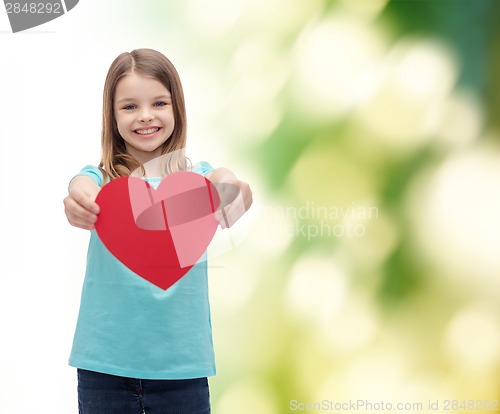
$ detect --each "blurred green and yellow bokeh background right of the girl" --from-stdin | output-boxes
[103,0,500,414]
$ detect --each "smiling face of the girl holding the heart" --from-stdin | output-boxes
[114,72,175,164]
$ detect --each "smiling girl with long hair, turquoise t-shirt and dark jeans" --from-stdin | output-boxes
[64,49,252,414]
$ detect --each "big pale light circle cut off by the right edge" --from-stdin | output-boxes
[409,146,500,293]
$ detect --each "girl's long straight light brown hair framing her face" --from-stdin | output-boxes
[99,49,187,183]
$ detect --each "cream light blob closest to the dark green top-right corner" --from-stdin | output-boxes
[357,39,457,152]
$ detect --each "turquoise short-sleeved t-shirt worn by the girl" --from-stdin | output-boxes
[69,162,215,379]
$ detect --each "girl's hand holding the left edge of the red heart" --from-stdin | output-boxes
[64,175,101,230]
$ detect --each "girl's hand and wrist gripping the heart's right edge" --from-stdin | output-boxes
[206,168,253,229]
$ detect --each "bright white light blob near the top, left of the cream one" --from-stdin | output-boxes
[294,17,385,119]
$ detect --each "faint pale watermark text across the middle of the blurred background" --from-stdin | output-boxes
[263,201,379,241]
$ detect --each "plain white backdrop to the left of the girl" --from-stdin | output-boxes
[0,0,227,414]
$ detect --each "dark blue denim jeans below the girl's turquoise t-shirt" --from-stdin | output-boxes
[77,369,210,414]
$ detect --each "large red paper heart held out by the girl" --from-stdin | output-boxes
[95,171,219,290]
